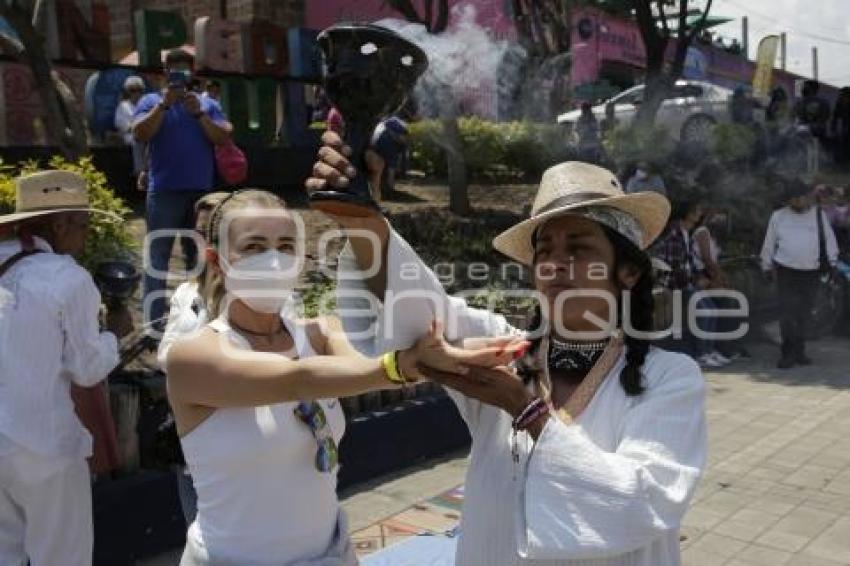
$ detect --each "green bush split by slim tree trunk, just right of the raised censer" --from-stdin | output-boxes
[409,117,570,178]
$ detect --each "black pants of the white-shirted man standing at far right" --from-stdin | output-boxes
[776,265,818,359]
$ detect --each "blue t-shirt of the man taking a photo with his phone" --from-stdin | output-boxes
[133,93,226,191]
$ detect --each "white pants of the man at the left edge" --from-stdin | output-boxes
[0,448,94,566]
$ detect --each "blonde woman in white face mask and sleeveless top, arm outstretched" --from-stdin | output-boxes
[166,191,525,566]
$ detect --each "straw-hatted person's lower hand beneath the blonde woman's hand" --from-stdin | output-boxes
[419,366,534,418]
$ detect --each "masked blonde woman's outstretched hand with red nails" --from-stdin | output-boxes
[399,321,530,380]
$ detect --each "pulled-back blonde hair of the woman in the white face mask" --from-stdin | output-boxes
[205,189,286,320]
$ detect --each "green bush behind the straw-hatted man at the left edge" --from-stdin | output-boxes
[0,156,138,271]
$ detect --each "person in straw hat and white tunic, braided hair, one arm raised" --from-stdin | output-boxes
[307,139,706,566]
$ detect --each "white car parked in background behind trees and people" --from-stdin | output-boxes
[558,80,732,141]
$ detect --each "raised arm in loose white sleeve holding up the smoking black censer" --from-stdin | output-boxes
[307,132,518,434]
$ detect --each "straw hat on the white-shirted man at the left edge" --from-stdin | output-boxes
[0,171,113,229]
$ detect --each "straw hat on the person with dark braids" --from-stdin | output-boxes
[493,161,670,265]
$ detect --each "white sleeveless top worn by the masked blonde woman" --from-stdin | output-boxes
[181,318,347,566]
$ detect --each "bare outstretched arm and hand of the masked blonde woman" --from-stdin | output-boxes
[166,322,511,408]
